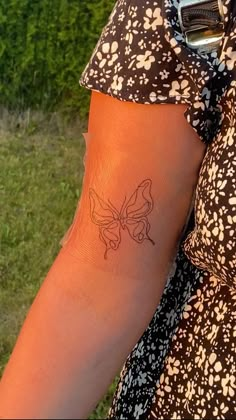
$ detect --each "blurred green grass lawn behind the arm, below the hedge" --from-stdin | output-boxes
[0,130,118,419]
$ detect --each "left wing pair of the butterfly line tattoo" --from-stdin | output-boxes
[89,188,121,259]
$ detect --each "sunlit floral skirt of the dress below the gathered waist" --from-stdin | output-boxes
[147,275,236,420]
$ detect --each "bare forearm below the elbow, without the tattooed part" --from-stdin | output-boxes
[0,250,157,419]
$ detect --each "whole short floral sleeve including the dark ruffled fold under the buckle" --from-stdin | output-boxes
[79,0,232,143]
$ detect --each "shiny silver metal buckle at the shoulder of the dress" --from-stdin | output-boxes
[178,0,224,53]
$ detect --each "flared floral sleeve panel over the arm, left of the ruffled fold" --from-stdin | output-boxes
[80,0,191,104]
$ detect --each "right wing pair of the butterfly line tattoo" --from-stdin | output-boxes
[122,179,155,245]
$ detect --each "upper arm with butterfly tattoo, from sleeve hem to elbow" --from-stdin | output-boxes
[60,91,205,286]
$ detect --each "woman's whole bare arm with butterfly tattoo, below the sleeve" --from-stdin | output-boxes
[0,91,205,419]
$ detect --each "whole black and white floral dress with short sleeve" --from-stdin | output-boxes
[76,0,236,420]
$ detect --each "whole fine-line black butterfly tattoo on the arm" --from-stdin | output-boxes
[89,179,155,259]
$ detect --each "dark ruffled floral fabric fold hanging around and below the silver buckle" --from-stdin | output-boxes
[162,0,234,144]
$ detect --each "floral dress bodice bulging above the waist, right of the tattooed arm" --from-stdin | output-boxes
[183,87,236,290]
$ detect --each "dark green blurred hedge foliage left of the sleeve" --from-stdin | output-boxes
[0,0,115,119]
